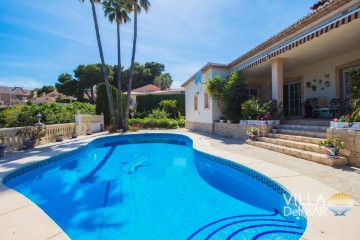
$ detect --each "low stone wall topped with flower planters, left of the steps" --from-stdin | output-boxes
[214,122,273,139]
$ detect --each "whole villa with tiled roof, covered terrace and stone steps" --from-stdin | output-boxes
[182,0,360,167]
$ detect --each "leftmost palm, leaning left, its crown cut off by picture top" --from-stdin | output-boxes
[80,0,116,125]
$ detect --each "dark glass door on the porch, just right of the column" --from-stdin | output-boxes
[284,82,301,117]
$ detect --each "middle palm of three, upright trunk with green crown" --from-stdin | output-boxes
[102,0,130,129]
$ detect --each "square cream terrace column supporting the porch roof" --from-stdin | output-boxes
[271,58,284,103]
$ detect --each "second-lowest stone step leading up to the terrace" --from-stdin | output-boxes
[259,137,326,154]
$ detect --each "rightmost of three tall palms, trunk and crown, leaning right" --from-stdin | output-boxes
[124,0,150,131]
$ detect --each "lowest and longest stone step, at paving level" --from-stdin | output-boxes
[246,140,348,167]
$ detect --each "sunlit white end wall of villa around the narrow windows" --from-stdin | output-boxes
[185,69,226,123]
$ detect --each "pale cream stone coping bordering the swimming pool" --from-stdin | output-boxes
[0,131,360,240]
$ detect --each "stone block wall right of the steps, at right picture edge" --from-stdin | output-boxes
[326,128,360,167]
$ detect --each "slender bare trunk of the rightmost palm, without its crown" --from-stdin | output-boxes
[124,6,137,131]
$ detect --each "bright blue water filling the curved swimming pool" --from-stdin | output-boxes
[4,134,306,240]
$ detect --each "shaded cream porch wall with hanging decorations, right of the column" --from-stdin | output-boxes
[284,49,360,99]
